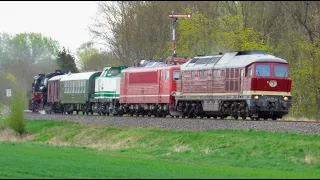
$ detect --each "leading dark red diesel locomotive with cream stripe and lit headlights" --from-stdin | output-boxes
[173,51,292,120]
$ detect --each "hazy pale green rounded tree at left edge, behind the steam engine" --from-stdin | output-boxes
[0,33,59,103]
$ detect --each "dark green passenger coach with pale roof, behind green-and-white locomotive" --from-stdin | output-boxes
[60,71,101,114]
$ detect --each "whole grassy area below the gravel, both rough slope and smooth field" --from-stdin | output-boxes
[0,120,320,179]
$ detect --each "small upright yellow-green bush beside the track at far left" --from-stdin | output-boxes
[7,89,27,135]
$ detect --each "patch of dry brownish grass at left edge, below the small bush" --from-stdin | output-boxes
[0,129,34,142]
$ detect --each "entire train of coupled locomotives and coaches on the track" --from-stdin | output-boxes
[29,51,292,120]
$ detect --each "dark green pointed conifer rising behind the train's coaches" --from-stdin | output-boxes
[57,47,79,73]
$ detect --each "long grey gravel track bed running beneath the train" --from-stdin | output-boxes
[25,112,320,134]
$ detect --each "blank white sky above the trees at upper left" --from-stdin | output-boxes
[0,1,97,54]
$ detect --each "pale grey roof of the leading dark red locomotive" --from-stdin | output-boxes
[181,51,288,70]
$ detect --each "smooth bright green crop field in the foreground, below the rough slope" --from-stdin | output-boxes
[0,143,319,178]
